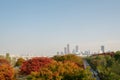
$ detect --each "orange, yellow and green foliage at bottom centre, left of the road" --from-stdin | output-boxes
[27,61,94,80]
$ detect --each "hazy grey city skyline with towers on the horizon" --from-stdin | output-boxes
[56,44,107,56]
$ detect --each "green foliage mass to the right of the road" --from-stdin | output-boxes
[88,51,120,80]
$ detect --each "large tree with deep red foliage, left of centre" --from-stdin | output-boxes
[20,57,52,75]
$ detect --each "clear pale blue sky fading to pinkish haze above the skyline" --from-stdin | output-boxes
[0,0,120,56]
